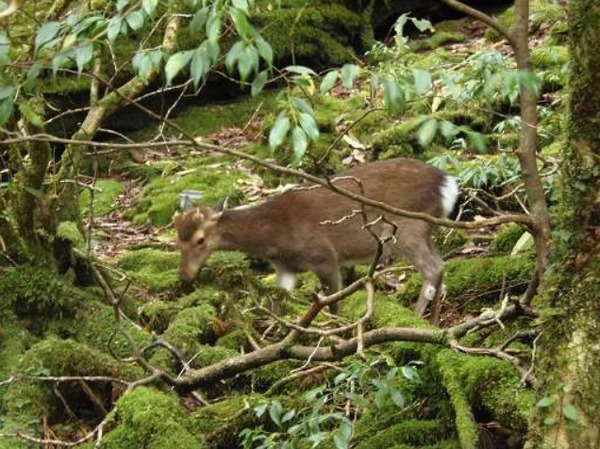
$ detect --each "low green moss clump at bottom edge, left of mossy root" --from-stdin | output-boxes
[354,419,446,449]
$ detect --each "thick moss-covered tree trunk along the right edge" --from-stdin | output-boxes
[527,0,600,449]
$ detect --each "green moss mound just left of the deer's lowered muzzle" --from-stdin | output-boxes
[117,248,181,296]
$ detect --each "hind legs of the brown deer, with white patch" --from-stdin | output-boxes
[397,226,444,323]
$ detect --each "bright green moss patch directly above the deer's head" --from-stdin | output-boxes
[136,163,245,226]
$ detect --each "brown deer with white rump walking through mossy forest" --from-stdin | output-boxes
[174,158,458,315]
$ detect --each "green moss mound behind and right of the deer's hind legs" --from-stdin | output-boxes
[396,255,534,310]
